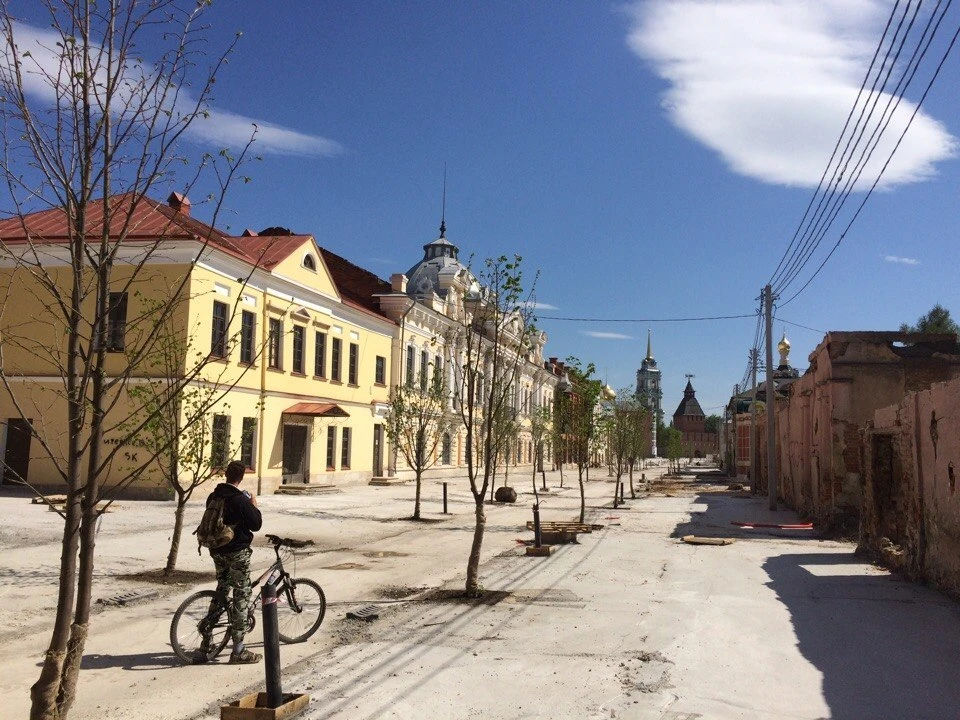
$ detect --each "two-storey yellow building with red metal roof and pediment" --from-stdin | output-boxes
[0,194,397,497]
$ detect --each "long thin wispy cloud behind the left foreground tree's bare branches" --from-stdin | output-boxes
[0,23,344,156]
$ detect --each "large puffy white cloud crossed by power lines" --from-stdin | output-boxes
[627,0,958,189]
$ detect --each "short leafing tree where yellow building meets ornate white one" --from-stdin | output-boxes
[385,367,454,520]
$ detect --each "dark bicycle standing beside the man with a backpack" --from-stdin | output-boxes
[170,535,327,663]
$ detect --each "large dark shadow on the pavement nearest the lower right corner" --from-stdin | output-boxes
[763,552,960,720]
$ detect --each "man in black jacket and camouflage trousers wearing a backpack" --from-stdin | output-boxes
[194,460,263,665]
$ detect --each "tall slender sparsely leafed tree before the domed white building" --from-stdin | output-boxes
[448,256,534,597]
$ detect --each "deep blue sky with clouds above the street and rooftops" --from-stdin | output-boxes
[7,0,960,416]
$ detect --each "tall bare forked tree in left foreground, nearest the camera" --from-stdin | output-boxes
[0,0,255,720]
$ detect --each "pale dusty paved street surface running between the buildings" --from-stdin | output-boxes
[0,464,960,720]
